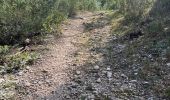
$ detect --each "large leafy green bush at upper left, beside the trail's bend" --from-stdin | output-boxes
[0,0,63,44]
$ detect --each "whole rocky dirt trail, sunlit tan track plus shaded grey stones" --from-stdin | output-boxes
[16,12,169,100]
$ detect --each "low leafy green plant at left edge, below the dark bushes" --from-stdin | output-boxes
[0,52,39,74]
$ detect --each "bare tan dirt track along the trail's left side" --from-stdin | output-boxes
[17,12,97,100]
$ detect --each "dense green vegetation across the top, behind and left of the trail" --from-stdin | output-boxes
[0,0,169,45]
